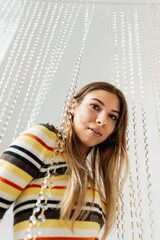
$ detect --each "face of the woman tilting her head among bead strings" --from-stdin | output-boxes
[73,90,120,153]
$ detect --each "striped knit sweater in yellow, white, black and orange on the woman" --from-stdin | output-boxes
[0,124,104,240]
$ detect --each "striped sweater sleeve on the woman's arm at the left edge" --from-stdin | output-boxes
[0,125,56,221]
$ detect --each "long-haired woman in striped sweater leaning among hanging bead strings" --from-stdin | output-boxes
[0,82,128,240]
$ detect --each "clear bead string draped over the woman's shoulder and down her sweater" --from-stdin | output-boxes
[25,4,93,240]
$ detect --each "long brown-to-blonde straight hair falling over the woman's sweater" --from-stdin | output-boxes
[58,82,129,239]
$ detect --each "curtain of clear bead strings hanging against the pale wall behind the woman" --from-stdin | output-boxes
[0,0,160,240]
